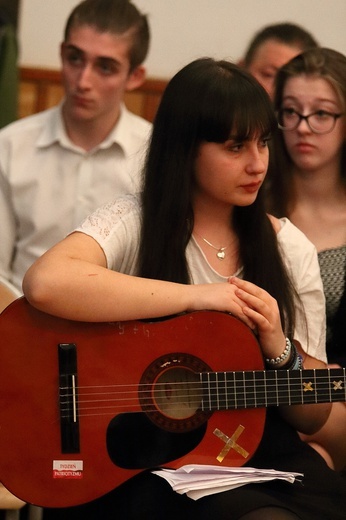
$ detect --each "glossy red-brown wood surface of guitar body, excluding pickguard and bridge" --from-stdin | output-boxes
[0,299,265,507]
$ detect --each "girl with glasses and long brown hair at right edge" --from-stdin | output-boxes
[267,48,346,470]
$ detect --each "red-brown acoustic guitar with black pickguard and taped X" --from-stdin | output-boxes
[0,298,346,507]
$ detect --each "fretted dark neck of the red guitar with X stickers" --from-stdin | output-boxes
[199,368,346,411]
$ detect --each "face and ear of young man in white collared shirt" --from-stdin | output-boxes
[61,25,144,125]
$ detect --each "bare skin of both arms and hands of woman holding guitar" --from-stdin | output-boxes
[23,232,331,433]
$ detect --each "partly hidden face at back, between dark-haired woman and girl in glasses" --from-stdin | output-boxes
[247,39,302,99]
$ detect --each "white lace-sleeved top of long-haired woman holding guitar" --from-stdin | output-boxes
[77,196,326,361]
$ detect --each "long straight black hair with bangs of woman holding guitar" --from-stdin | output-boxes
[139,58,294,334]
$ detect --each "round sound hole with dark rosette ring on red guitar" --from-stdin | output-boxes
[139,353,211,432]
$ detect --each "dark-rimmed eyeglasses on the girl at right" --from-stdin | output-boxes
[277,108,344,134]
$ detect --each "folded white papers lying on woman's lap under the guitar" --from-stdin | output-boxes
[152,464,304,500]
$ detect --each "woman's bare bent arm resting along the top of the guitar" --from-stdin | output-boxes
[23,232,252,326]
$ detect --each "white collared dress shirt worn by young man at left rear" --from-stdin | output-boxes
[0,105,151,289]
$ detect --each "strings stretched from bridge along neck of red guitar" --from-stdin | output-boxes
[60,369,346,417]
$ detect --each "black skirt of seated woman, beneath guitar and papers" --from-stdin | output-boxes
[43,409,346,520]
